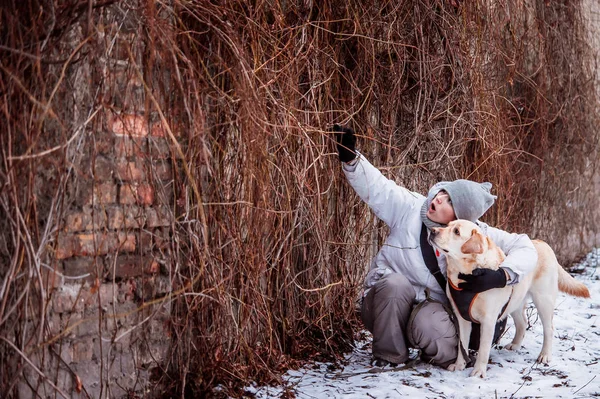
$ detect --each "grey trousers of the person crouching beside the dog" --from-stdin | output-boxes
[361,273,458,367]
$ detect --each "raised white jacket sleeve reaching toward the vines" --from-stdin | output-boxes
[343,154,424,228]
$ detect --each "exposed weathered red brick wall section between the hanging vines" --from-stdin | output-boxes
[19,12,179,398]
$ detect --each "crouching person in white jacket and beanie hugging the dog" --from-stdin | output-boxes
[333,125,537,367]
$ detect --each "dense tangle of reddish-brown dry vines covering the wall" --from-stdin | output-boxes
[0,0,599,397]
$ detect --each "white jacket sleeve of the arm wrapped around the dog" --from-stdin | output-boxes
[479,222,538,285]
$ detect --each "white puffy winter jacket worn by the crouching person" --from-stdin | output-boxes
[342,154,537,302]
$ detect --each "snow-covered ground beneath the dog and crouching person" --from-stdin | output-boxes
[247,249,600,399]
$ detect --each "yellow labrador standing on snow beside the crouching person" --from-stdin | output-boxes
[432,220,590,378]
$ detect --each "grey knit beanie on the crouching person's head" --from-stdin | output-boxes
[442,179,496,222]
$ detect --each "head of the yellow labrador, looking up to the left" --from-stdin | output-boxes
[431,220,489,259]
